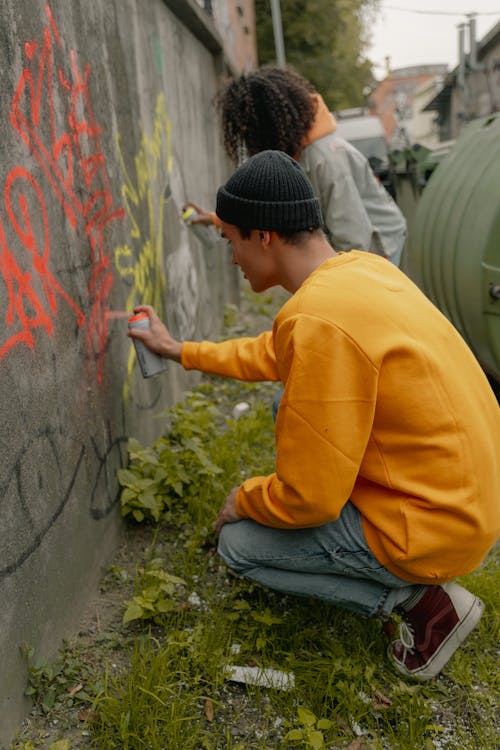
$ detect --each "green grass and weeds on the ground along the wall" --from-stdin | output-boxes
[12,284,500,750]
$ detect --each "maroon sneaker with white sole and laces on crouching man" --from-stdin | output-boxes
[388,583,484,680]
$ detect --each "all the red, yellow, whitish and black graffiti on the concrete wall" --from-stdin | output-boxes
[0,4,203,580]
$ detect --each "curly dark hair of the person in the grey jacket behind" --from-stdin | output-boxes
[216,65,316,163]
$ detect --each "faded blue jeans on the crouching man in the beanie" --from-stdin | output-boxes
[218,502,420,618]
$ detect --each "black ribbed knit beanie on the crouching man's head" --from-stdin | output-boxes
[216,151,323,234]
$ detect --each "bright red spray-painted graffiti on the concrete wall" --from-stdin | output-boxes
[0,5,125,381]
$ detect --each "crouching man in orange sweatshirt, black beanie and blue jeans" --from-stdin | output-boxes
[130,151,500,680]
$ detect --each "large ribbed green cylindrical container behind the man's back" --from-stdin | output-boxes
[407,114,500,383]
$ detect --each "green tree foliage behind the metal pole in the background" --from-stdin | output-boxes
[255,0,378,109]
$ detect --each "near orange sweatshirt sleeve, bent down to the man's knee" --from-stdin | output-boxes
[236,315,378,528]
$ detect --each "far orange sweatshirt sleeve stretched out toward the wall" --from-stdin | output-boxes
[181,331,280,382]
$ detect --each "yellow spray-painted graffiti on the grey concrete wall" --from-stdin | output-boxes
[115,94,172,400]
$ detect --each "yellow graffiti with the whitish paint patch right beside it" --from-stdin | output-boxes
[115,94,203,405]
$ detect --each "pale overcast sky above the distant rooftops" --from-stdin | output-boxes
[366,0,500,80]
